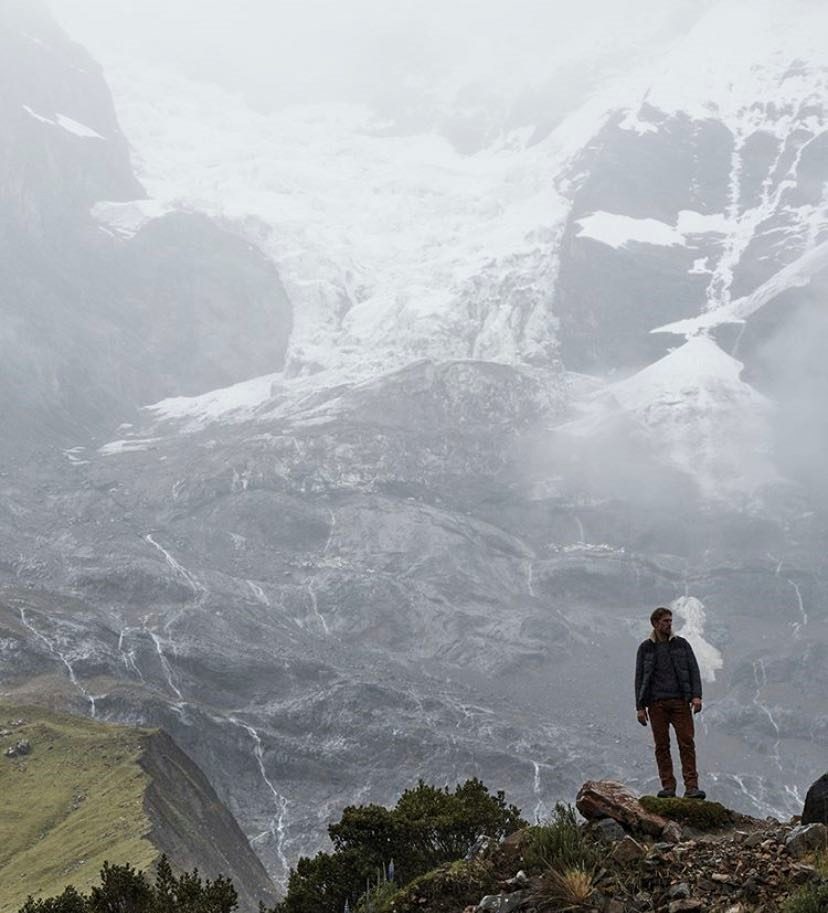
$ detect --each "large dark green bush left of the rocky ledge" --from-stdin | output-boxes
[273,778,526,913]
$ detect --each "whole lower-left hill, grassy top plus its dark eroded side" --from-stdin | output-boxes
[0,702,275,911]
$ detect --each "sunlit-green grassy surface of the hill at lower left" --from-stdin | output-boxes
[0,701,159,913]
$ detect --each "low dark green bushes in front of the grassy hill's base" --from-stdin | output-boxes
[20,856,237,913]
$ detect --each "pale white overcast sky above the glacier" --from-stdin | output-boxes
[49,0,713,106]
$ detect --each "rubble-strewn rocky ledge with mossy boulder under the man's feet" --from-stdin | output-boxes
[388,780,828,913]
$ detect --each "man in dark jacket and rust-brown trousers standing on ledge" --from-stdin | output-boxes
[635,607,705,799]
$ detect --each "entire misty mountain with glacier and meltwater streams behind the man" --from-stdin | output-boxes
[0,3,828,896]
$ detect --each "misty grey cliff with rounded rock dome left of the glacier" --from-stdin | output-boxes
[0,0,291,447]
